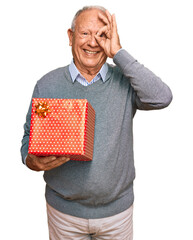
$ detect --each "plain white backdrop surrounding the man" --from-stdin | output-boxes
[0,0,193,240]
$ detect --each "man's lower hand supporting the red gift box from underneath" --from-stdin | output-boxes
[26,154,70,171]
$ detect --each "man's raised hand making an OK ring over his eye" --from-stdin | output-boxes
[95,11,121,58]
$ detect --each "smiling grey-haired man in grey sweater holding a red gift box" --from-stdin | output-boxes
[21,6,172,240]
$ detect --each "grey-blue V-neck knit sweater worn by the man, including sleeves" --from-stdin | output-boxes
[21,50,172,218]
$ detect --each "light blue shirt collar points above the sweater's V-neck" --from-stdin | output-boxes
[69,60,108,82]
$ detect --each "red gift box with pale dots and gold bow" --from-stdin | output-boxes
[28,98,95,161]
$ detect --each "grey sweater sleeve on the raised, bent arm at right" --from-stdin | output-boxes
[113,49,172,110]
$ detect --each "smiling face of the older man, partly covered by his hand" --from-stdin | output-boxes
[68,9,107,72]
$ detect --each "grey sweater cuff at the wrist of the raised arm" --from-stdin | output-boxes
[113,48,136,71]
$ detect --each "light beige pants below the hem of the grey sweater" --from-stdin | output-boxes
[47,204,133,240]
